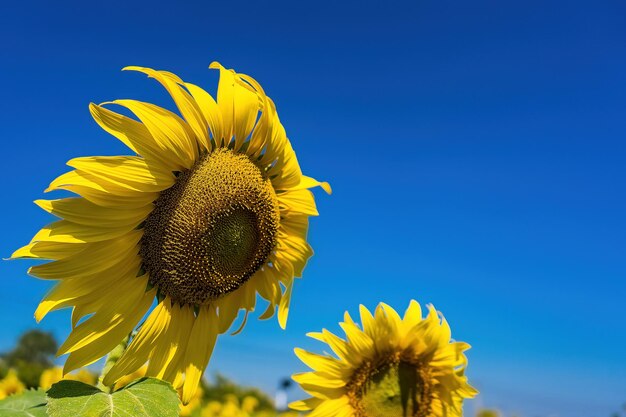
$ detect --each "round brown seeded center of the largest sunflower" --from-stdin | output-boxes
[140,148,280,305]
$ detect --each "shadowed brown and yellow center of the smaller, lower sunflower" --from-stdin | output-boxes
[348,358,432,417]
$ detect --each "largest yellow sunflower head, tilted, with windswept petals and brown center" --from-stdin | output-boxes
[12,62,331,403]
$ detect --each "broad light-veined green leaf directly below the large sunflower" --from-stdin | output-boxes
[48,378,179,417]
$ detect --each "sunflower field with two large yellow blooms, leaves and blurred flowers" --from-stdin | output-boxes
[0,62,478,417]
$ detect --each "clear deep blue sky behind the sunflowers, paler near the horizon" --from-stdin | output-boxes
[0,0,626,417]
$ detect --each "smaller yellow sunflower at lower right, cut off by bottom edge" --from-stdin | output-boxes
[290,300,477,417]
